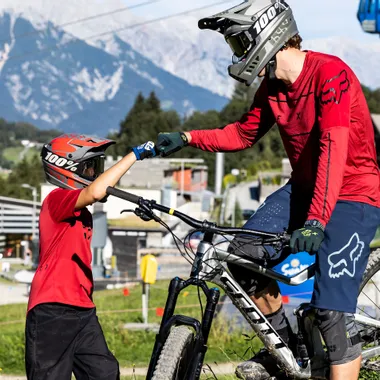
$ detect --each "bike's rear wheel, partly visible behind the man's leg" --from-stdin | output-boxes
[356,249,380,372]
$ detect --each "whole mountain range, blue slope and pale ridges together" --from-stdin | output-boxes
[0,0,380,134]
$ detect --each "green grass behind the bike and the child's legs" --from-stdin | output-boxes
[0,281,379,380]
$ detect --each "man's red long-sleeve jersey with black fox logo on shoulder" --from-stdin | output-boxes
[190,51,380,225]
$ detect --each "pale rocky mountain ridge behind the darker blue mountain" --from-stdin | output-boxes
[0,0,380,97]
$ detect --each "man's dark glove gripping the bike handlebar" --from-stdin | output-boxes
[290,220,325,255]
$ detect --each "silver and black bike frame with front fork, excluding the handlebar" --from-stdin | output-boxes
[147,234,380,380]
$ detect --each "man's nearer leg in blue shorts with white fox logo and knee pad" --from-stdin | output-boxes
[311,201,378,380]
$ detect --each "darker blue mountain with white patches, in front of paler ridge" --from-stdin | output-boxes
[0,11,227,134]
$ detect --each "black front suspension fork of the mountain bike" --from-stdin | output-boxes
[146,277,220,380]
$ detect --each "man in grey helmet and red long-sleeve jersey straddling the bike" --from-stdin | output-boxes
[157,0,380,380]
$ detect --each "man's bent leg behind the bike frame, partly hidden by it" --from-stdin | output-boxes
[228,184,309,343]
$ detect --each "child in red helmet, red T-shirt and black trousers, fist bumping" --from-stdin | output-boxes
[25,134,155,380]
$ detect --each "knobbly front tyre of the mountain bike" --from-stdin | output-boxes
[152,326,194,380]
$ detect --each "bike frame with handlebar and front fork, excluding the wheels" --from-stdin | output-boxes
[107,187,380,380]
